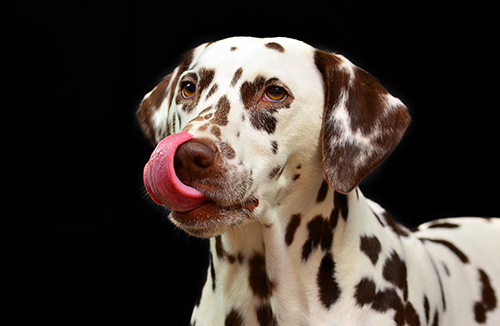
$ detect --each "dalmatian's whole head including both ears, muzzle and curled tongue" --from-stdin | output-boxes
[137,37,410,236]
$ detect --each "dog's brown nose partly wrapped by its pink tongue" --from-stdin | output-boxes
[174,140,217,186]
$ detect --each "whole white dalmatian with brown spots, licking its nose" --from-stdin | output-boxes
[137,37,500,326]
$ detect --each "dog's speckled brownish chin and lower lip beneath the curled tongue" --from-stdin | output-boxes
[170,197,259,238]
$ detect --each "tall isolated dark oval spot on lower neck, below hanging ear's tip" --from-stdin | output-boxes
[317,252,341,309]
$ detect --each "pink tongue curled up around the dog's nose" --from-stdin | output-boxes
[143,132,207,212]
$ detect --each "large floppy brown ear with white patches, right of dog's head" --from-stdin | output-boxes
[315,50,411,193]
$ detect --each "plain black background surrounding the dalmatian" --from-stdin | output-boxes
[29,1,500,325]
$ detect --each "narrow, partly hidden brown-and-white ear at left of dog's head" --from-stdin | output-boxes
[136,50,194,146]
